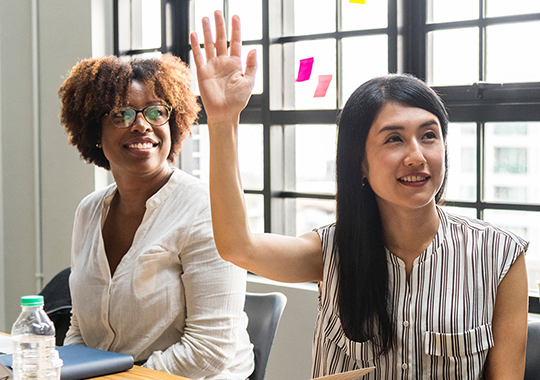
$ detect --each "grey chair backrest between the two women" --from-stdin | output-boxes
[244,292,287,380]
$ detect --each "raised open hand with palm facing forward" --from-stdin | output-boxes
[190,11,257,121]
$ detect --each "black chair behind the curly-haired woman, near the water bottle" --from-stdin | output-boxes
[39,268,71,346]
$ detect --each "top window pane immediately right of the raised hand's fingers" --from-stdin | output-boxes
[229,0,262,41]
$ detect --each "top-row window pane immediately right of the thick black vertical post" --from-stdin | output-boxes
[427,0,479,23]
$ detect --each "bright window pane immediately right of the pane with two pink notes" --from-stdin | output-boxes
[341,34,388,103]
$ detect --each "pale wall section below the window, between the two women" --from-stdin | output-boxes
[247,275,318,380]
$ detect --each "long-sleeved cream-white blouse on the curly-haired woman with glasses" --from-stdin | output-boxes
[65,169,254,379]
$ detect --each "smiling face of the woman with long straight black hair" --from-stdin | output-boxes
[363,103,445,211]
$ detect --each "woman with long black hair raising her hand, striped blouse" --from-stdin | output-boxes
[191,12,528,379]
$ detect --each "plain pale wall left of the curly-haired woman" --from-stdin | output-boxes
[0,0,112,332]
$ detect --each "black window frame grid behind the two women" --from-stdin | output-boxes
[114,0,540,313]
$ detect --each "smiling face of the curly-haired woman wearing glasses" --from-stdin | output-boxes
[101,80,171,178]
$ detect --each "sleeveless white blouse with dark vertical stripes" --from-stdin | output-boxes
[312,208,528,380]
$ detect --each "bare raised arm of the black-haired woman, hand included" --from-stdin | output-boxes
[191,11,323,282]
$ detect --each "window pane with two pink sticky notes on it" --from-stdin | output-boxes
[283,39,337,109]
